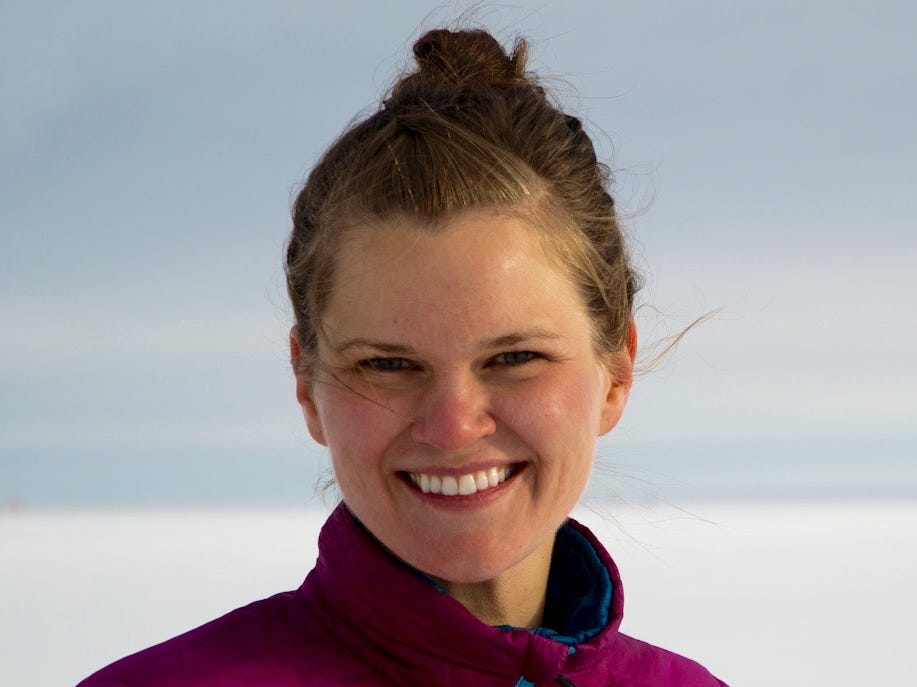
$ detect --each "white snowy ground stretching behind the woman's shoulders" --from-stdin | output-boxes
[0,502,917,687]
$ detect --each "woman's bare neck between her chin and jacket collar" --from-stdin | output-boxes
[436,542,553,627]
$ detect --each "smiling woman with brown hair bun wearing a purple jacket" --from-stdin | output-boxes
[82,30,723,687]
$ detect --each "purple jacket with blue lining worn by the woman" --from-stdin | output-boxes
[78,504,724,687]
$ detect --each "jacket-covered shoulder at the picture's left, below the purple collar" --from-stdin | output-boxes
[77,591,374,687]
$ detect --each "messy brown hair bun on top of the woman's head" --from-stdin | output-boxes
[414,29,527,88]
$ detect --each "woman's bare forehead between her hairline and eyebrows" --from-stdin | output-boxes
[323,213,589,346]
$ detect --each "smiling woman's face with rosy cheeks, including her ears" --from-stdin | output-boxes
[293,213,633,582]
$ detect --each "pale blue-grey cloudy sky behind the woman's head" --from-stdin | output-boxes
[0,1,917,509]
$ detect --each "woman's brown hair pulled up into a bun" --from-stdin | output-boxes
[286,29,639,367]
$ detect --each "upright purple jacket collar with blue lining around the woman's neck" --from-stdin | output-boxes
[300,503,623,684]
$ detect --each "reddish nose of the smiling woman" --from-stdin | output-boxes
[411,374,497,451]
